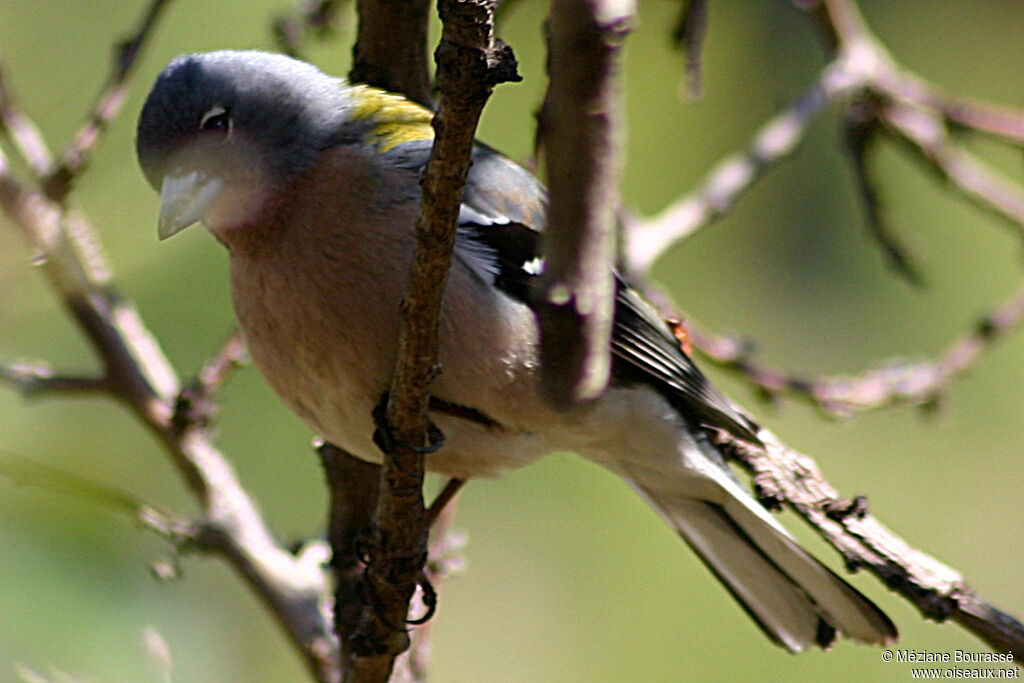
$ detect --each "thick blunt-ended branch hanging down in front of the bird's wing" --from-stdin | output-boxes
[538,0,634,408]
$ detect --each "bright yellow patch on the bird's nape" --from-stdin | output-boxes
[351,85,434,152]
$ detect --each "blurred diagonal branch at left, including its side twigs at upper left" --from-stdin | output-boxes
[0,10,337,681]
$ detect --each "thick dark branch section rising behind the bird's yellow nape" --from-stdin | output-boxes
[348,0,433,106]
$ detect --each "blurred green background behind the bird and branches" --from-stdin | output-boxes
[0,0,1024,682]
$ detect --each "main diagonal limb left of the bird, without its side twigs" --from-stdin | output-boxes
[0,163,330,679]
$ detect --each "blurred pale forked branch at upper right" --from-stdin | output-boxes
[627,0,1024,273]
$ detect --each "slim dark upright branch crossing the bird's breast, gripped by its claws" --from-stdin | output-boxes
[344,0,518,681]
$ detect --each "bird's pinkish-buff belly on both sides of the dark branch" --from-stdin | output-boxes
[231,248,553,478]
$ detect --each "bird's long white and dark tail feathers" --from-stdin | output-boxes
[628,444,897,652]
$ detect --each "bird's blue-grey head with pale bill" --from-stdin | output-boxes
[136,50,351,239]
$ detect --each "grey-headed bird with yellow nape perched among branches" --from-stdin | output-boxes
[137,51,896,651]
